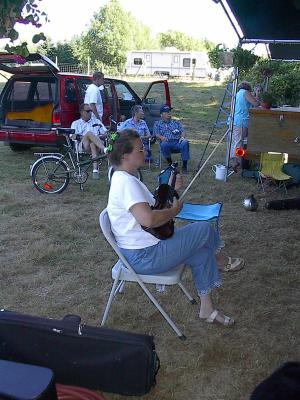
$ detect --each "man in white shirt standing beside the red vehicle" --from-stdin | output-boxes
[84,72,104,121]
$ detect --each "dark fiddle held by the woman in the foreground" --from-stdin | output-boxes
[142,162,179,240]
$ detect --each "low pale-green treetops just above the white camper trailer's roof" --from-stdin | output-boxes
[158,30,213,51]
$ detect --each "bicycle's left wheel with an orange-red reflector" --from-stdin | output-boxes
[32,156,70,194]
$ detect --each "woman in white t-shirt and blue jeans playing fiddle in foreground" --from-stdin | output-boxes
[107,129,243,326]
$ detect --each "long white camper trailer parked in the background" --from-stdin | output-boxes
[125,49,211,78]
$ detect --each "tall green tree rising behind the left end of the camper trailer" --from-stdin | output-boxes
[75,0,152,71]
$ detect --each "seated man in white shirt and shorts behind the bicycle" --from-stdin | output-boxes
[71,104,107,179]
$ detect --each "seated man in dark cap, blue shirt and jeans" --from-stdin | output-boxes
[153,105,190,174]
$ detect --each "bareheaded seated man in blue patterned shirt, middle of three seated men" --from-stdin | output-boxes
[119,105,152,162]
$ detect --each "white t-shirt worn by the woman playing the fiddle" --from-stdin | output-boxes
[107,171,159,249]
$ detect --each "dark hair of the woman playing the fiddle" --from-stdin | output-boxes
[108,129,140,167]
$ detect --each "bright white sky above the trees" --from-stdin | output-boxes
[13,0,238,47]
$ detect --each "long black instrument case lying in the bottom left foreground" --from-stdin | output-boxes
[0,310,159,396]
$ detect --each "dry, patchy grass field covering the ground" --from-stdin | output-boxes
[0,82,300,400]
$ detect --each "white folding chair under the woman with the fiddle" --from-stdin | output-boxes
[99,209,196,340]
